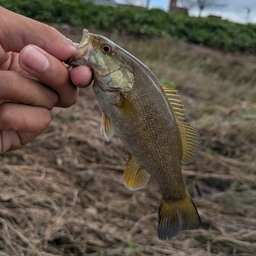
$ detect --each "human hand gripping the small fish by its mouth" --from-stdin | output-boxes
[0,7,91,154]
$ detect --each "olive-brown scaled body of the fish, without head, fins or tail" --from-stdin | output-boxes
[94,65,185,200]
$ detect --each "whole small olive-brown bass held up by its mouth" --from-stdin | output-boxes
[67,29,201,240]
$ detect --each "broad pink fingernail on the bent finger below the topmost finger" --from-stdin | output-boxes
[23,46,50,73]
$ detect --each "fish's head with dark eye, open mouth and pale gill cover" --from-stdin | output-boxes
[68,29,134,91]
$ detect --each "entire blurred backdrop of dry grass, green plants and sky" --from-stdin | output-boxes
[0,0,256,256]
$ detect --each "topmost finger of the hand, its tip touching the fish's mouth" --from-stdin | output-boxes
[0,6,75,61]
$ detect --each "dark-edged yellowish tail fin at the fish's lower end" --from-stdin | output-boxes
[157,191,201,240]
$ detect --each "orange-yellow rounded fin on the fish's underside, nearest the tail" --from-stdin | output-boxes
[123,154,150,190]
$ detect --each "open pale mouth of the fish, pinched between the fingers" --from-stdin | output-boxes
[65,29,93,66]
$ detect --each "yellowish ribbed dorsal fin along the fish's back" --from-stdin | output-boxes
[161,85,201,164]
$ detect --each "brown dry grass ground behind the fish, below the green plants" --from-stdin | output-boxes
[0,26,256,256]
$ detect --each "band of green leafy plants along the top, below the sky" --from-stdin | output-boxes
[0,0,256,54]
